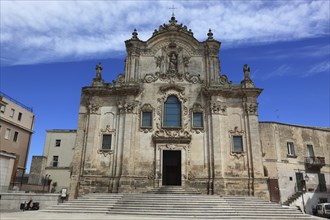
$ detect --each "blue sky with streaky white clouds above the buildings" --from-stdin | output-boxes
[0,0,330,173]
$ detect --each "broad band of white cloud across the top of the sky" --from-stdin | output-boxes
[0,1,330,65]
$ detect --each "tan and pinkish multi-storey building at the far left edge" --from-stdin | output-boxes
[0,92,35,191]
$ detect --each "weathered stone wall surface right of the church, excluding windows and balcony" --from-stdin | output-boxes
[259,122,330,202]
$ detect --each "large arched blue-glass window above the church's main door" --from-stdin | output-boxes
[163,95,181,127]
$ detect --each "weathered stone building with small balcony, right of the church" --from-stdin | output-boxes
[259,122,330,208]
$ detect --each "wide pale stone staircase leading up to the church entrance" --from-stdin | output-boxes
[42,187,312,219]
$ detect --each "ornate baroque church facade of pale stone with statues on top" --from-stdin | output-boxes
[70,16,269,198]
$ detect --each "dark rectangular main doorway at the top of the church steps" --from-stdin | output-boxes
[163,150,181,186]
